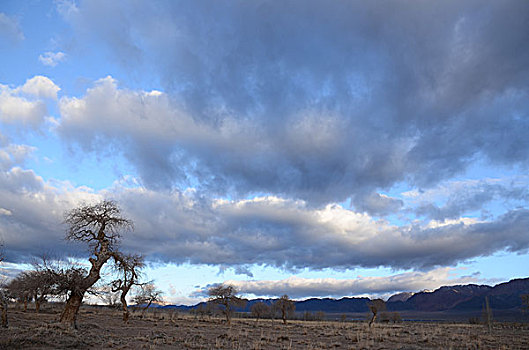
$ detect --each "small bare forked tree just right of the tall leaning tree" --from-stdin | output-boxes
[112,254,144,323]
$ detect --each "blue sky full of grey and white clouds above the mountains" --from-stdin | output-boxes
[0,0,529,304]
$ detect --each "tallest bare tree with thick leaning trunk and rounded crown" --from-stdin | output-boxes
[60,200,133,328]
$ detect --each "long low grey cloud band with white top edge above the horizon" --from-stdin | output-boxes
[0,154,529,274]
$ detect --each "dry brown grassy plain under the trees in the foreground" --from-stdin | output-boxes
[0,307,529,350]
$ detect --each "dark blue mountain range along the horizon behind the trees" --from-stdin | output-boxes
[163,278,529,313]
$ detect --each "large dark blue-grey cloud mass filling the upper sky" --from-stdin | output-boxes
[52,1,529,204]
